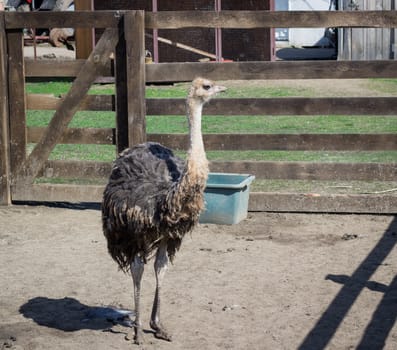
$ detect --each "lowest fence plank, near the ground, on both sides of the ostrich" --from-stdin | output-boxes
[12,184,397,214]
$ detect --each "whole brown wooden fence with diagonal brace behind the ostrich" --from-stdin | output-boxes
[0,11,397,213]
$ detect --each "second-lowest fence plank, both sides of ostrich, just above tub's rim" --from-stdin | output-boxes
[35,160,397,181]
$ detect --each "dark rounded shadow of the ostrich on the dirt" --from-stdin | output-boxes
[19,297,134,333]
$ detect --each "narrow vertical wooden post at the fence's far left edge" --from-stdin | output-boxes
[0,12,11,205]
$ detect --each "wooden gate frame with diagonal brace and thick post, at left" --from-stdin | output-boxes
[0,11,145,204]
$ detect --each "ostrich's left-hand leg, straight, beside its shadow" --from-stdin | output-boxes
[127,255,145,344]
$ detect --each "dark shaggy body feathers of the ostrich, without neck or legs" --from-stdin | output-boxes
[102,142,206,271]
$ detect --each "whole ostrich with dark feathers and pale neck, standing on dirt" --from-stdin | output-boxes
[102,78,226,344]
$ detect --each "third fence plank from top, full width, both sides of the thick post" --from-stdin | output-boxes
[26,94,397,117]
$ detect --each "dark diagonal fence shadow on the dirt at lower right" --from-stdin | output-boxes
[298,217,397,350]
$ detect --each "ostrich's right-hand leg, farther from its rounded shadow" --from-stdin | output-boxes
[150,242,171,341]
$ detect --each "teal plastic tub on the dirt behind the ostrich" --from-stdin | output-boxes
[200,173,255,225]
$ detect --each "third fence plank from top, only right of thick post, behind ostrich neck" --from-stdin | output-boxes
[146,97,397,117]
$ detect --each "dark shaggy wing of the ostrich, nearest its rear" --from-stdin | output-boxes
[102,143,185,270]
